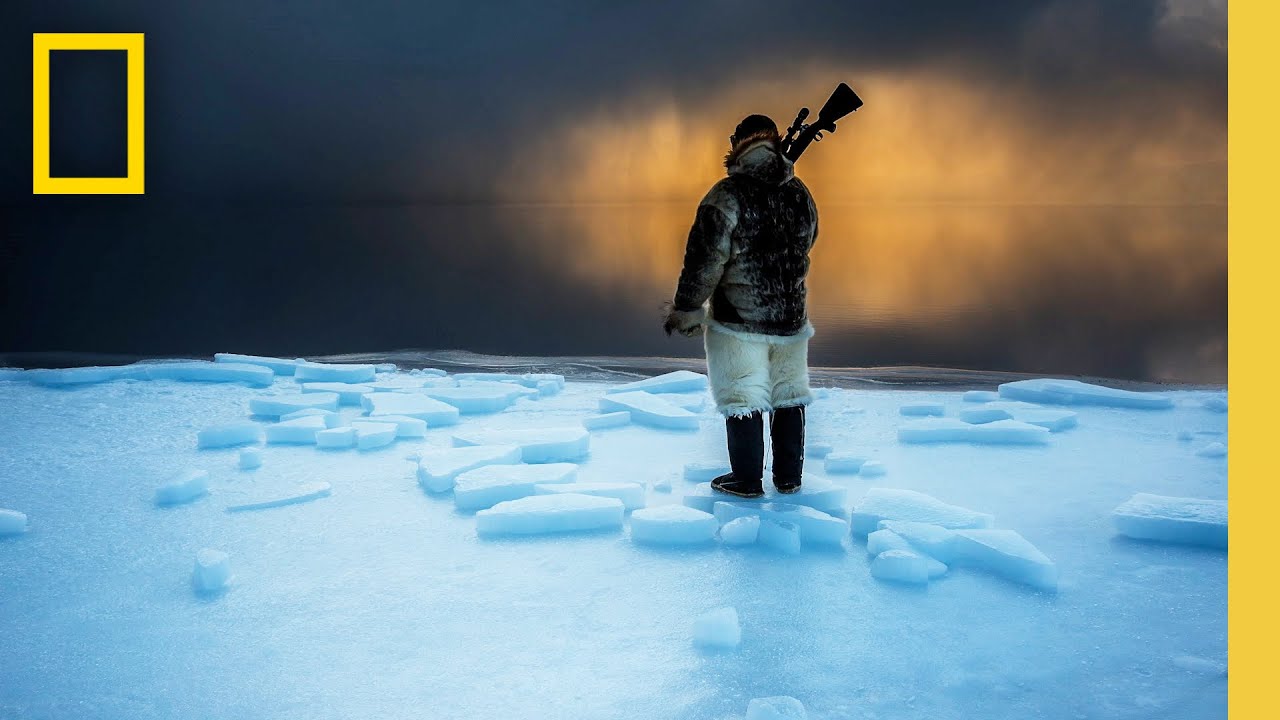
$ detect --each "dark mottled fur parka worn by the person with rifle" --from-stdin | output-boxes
[673,133,818,337]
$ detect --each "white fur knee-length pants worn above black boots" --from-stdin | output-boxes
[703,322,813,416]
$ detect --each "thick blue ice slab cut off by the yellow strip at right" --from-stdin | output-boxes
[1112,492,1228,548]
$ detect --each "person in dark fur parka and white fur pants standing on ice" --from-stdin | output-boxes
[664,115,818,497]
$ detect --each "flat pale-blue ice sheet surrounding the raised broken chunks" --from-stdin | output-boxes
[0,372,1228,720]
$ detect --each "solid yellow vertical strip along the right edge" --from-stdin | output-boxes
[1228,0,1280,720]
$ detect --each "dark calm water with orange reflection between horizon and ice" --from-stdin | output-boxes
[0,196,1226,383]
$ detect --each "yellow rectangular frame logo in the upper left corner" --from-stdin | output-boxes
[31,32,146,195]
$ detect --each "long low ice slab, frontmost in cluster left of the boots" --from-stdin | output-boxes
[476,493,623,536]
